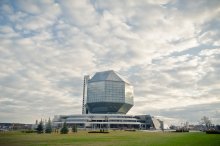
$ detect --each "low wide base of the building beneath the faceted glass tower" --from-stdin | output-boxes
[53,114,162,130]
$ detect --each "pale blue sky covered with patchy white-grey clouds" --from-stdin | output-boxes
[0,0,220,124]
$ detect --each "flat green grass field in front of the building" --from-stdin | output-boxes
[0,131,220,146]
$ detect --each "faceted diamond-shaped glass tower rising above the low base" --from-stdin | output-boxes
[85,70,134,114]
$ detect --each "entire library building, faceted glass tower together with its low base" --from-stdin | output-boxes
[53,70,164,130]
